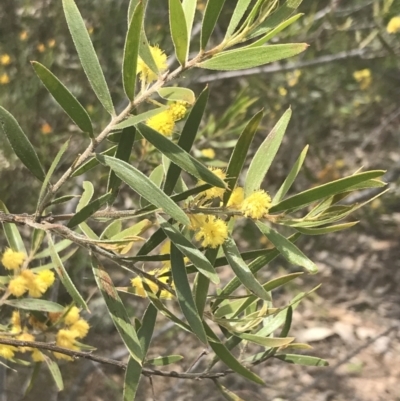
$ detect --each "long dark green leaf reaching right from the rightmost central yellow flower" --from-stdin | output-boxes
[270,170,385,213]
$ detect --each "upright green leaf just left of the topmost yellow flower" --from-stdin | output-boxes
[122,2,143,100]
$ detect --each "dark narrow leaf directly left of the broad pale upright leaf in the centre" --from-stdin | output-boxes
[224,111,264,204]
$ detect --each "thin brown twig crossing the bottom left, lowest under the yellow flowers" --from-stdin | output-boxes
[0,337,228,380]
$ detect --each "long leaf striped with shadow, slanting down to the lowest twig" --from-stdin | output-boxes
[92,256,143,365]
